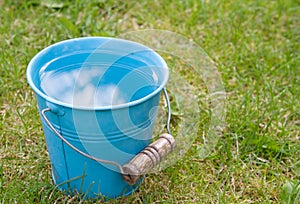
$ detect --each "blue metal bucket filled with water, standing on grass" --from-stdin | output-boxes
[26,37,169,198]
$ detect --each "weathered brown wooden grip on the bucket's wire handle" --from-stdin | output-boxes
[122,134,176,185]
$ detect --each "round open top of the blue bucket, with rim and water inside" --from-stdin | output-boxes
[27,37,168,108]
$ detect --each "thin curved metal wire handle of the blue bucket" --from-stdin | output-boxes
[41,88,171,174]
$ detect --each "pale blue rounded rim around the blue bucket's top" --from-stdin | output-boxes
[26,36,170,110]
